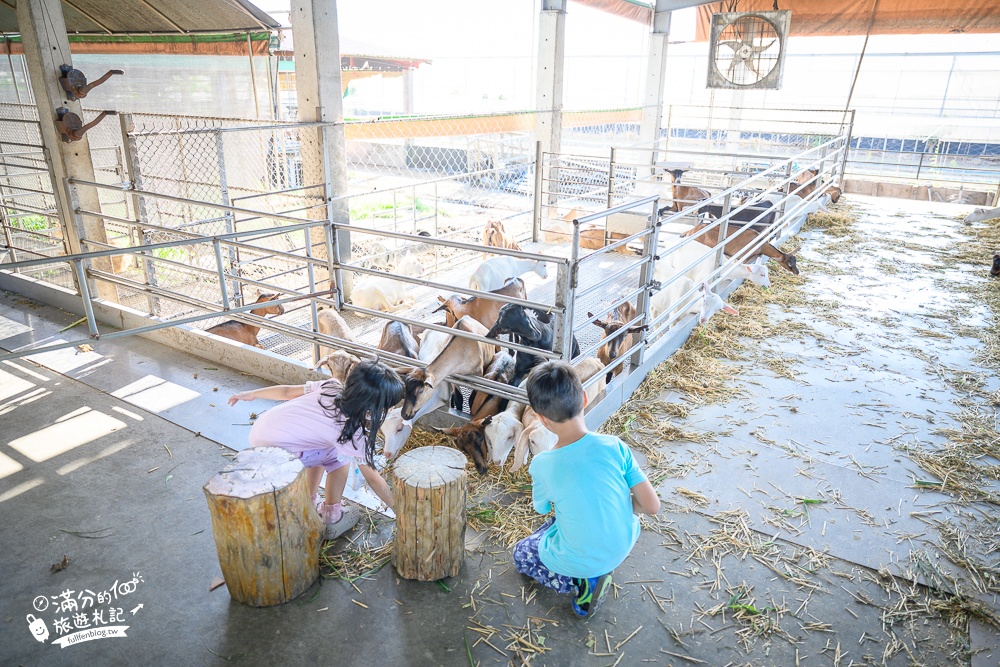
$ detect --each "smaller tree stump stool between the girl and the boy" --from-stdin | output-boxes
[392,447,467,581]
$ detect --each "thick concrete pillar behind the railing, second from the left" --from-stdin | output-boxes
[289,0,351,292]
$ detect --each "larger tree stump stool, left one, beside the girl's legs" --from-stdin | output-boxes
[203,447,324,607]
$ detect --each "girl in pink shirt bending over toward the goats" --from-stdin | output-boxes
[229,361,403,540]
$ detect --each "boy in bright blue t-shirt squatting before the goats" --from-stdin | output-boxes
[514,361,660,616]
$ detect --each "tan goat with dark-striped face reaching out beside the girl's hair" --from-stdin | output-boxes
[400,316,493,424]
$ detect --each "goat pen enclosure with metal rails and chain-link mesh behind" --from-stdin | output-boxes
[0,100,850,434]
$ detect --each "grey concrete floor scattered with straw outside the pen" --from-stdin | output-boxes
[0,199,1000,667]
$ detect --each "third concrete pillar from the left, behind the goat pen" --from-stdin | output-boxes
[535,0,566,153]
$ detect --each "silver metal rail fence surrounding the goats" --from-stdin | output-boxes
[2,113,847,422]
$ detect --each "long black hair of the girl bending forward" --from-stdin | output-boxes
[320,361,403,466]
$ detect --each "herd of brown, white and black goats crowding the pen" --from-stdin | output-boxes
[207,171,840,473]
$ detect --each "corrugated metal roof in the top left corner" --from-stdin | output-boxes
[0,0,279,35]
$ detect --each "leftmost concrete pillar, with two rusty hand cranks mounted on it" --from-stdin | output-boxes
[17,0,118,302]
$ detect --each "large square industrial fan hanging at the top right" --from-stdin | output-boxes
[708,10,792,90]
